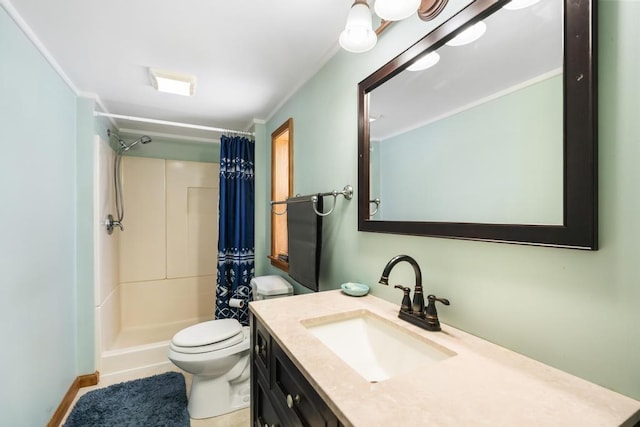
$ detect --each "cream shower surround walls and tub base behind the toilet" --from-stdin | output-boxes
[95,137,219,376]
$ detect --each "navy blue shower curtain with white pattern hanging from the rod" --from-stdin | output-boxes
[216,135,255,325]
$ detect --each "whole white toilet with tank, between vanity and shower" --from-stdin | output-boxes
[169,275,293,419]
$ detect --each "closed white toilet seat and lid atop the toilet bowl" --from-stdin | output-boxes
[170,319,245,354]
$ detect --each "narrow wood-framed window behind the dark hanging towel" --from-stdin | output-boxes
[268,117,293,271]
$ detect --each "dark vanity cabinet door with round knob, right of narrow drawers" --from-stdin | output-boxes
[270,341,338,427]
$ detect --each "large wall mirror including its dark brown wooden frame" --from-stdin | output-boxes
[358,0,597,250]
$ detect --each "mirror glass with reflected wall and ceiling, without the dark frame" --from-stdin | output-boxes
[369,0,563,225]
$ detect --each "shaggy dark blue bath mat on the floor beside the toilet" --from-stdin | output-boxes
[64,372,189,427]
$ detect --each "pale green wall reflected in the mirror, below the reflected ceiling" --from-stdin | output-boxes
[378,75,564,225]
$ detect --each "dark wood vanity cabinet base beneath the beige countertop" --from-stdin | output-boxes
[251,314,342,427]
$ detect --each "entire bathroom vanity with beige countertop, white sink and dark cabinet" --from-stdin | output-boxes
[250,290,640,427]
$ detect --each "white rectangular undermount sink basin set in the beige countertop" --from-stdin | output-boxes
[302,310,456,383]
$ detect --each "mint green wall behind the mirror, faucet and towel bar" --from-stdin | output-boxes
[256,0,640,398]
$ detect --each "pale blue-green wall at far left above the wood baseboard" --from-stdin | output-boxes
[0,8,78,426]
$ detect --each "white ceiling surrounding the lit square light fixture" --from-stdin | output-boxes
[2,0,352,138]
